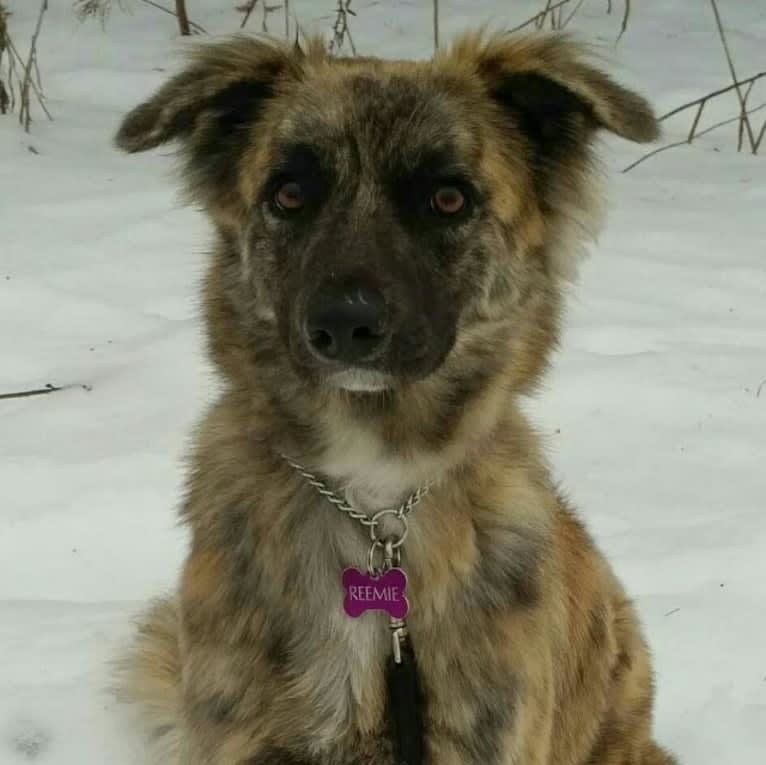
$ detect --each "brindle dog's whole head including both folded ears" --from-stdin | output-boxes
[117,36,656,396]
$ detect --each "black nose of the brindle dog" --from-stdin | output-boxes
[306,284,387,364]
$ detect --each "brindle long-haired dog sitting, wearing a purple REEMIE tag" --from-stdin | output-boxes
[116,32,676,765]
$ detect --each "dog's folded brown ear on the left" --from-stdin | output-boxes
[115,37,303,153]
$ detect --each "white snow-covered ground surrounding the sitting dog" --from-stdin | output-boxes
[0,0,766,765]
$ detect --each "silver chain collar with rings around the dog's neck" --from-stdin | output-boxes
[282,455,431,575]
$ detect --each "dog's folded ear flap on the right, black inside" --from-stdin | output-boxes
[453,35,658,153]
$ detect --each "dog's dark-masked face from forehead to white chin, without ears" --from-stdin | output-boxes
[243,70,483,390]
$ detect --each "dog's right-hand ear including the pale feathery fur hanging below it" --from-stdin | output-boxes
[444,33,659,280]
